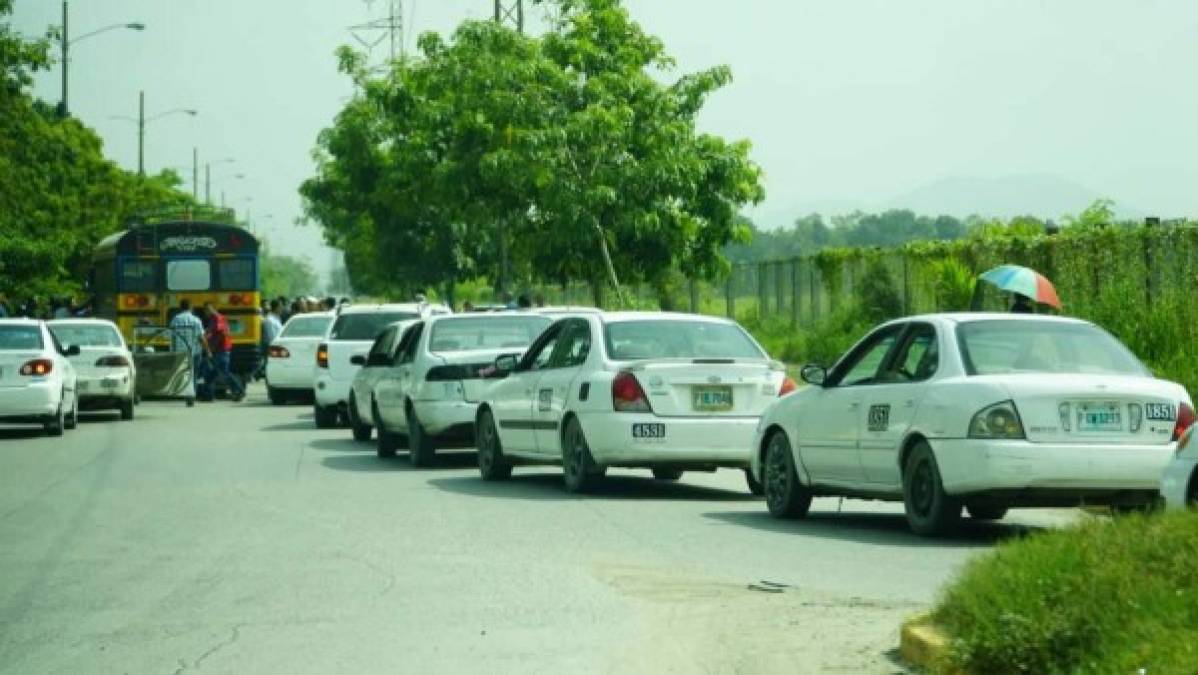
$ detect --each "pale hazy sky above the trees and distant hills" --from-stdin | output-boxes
[13,0,1198,281]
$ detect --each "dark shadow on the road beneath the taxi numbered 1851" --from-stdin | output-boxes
[703,505,1040,548]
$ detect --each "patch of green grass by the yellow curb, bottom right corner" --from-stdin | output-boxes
[933,513,1198,674]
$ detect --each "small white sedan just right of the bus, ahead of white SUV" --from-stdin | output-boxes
[266,312,333,405]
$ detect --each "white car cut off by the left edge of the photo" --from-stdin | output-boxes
[0,319,79,436]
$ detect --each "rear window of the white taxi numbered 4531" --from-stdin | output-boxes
[605,320,766,361]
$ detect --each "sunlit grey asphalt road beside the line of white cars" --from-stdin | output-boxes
[0,388,1072,673]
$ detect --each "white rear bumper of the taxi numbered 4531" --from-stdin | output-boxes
[579,412,758,468]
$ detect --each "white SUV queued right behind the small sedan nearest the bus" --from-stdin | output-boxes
[313,302,449,429]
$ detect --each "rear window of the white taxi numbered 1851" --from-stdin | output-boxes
[957,320,1148,375]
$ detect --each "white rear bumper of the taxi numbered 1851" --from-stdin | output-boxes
[932,439,1175,496]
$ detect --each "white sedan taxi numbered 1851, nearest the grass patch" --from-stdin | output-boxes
[754,314,1194,535]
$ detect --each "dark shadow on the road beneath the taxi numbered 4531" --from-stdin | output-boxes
[429,474,757,501]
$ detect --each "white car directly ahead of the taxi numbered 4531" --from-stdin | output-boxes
[371,312,552,466]
